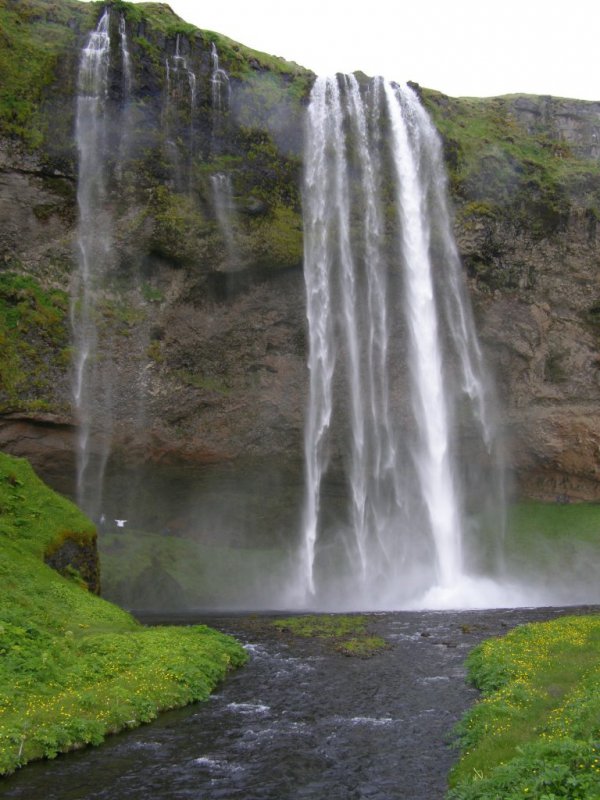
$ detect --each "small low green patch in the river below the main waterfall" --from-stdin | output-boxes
[273,614,388,658]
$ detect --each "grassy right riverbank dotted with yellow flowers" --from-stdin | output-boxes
[448,615,600,800]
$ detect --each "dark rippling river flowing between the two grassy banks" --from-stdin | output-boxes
[0,609,587,800]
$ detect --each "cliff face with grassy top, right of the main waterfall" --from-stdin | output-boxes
[426,94,600,500]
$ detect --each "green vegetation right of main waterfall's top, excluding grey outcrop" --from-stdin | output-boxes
[422,90,600,237]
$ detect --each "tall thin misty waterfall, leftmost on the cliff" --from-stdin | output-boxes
[70,8,131,519]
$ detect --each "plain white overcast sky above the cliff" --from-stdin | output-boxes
[90,0,600,100]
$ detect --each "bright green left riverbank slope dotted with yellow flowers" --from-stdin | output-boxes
[0,454,246,774]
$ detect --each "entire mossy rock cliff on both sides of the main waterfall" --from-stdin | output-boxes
[0,0,600,499]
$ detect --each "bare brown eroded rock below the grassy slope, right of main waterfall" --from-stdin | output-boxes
[458,212,600,500]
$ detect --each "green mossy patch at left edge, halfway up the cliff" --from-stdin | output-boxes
[0,272,70,411]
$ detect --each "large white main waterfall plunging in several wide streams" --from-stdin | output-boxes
[292,76,503,608]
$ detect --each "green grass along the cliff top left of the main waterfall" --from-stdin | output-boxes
[0,0,312,148]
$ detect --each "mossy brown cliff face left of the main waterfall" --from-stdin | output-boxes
[0,0,312,489]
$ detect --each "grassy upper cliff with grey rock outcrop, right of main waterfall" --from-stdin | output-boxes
[420,89,600,235]
